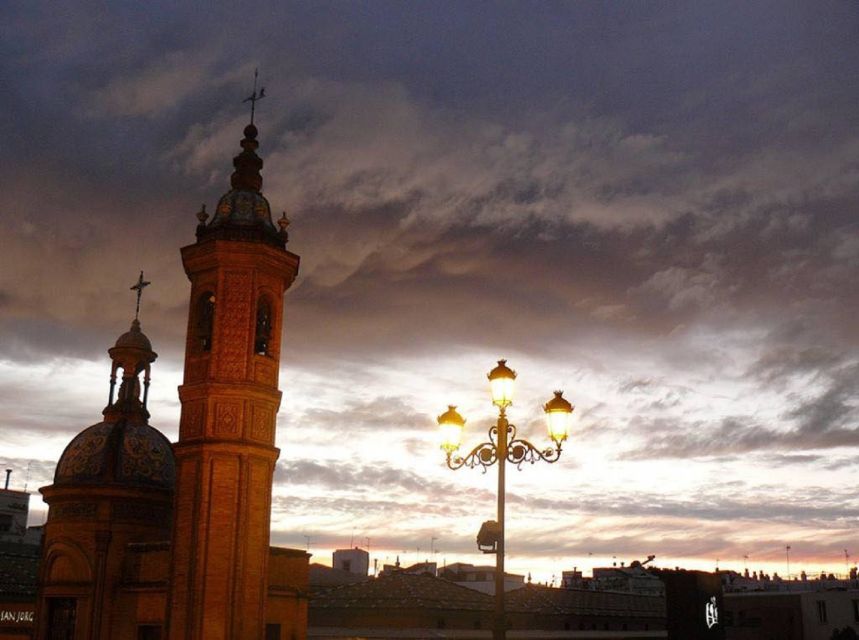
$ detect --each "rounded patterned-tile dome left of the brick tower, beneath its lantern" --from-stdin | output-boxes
[54,418,176,491]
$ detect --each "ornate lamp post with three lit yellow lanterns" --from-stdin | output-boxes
[438,360,573,640]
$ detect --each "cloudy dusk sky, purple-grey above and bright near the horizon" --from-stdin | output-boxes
[0,1,859,581]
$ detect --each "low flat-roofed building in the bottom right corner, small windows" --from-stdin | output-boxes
[725,589,859,640]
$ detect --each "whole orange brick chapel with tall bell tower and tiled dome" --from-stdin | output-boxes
[29,125,309,640]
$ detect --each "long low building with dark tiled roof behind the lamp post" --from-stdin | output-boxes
[307,572,667,640]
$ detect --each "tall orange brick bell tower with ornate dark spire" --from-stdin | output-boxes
[168,124,299,640]
